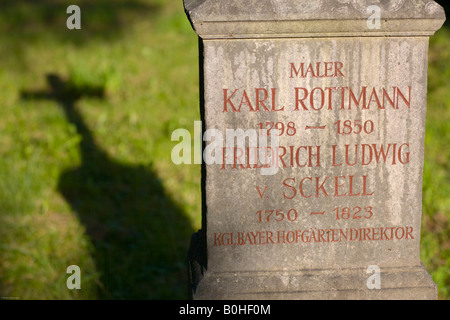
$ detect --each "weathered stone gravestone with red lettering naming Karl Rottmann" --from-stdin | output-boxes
[184,0,445,299]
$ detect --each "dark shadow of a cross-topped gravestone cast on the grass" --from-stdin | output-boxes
[22,74,193,299]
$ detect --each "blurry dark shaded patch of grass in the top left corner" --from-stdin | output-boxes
[0,0,162,72]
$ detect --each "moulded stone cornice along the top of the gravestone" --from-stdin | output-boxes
[184,0,445,39]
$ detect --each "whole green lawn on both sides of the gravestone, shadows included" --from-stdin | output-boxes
[0,0,450,299]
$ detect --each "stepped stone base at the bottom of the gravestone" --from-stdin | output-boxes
[192,265,437,300]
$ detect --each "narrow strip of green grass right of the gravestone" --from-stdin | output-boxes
[421,22,450,299]
